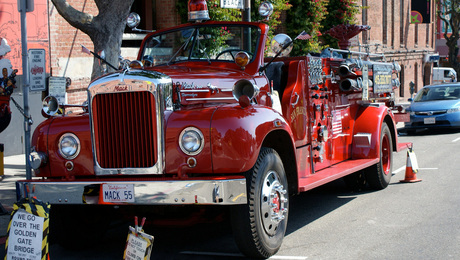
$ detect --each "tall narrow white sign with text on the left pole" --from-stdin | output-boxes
[28,49,46,91]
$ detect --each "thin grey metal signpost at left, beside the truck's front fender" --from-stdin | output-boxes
[18,0,34,180]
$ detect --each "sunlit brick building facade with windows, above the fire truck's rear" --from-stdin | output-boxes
[354,0,437,103]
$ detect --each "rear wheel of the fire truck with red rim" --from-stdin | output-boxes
[364,123,393,190]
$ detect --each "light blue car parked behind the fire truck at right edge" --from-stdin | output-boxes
[405,83,460,133]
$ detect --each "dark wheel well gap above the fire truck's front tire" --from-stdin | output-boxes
[262,130,298,194]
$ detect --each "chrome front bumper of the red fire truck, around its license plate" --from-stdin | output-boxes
[16,176,247,205]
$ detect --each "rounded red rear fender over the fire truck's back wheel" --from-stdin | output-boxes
[352,103,395,159]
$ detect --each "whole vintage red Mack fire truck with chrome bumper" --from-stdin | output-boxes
[17,1,406,257]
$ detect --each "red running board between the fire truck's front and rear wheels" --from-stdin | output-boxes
[299,158,379,192]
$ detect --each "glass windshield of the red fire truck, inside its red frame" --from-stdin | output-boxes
[142,25,260,67]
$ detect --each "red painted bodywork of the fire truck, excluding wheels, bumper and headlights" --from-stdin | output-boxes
[18,22,406,204]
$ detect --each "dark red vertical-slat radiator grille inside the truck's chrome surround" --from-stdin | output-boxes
[92,91,158,169]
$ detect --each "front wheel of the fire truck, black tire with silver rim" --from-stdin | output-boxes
[231,148,289,258]
